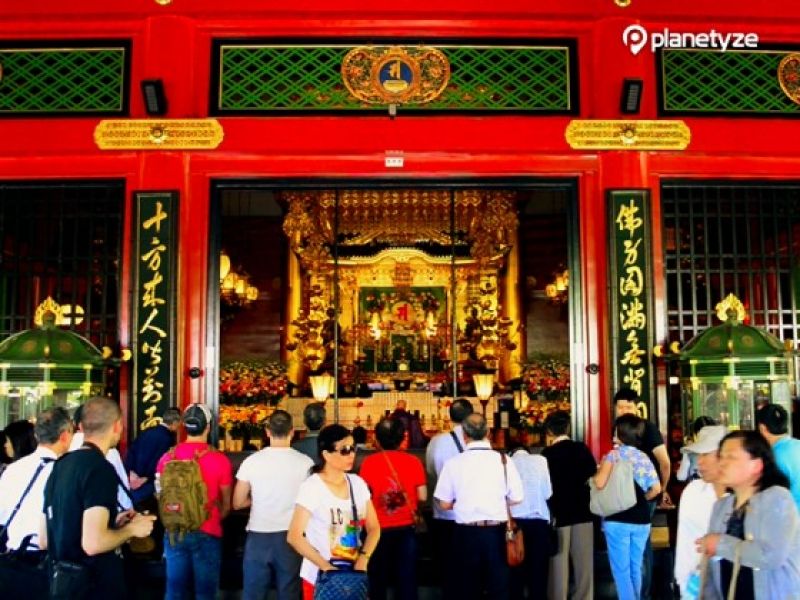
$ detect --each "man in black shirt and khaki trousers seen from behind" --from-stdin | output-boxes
[542,411,597,600]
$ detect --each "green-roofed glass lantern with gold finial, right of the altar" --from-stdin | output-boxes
[672,294,794,433]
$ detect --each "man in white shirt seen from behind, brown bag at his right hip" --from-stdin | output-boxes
[433,413,524,599]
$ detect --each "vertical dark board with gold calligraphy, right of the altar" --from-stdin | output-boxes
[608,190,655,419]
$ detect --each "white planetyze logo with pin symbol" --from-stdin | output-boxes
[622,25,758,56]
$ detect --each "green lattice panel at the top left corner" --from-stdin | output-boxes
[0,47,126,114]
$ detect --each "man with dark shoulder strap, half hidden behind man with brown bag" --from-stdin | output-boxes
[425,398,473,600]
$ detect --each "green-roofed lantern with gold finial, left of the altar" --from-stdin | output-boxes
[0,298,110,427]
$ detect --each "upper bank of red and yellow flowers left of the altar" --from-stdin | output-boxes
[219,361,289,406]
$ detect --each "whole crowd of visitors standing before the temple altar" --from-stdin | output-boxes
[0,389,800,600]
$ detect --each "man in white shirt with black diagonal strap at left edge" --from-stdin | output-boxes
[0,407,72,598]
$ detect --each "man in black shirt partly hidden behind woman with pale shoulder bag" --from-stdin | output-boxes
[614,388,675,600]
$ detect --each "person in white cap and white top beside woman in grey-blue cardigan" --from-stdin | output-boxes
[675,425,728,597]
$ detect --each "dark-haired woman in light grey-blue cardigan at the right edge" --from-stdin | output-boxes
[697,431,800,600]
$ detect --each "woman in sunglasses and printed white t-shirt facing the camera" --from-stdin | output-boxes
[287,424,380,600]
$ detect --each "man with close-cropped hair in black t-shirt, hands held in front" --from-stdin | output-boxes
[40,398,155,600]
